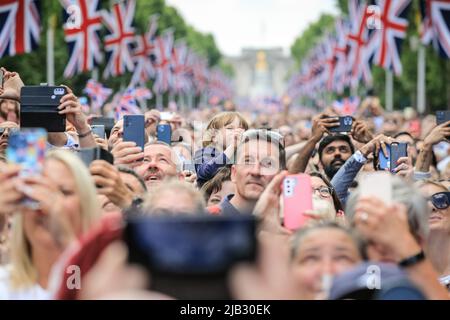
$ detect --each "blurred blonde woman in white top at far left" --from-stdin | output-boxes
[0,150,100,299]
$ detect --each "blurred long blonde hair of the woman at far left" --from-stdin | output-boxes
[11,150,101,289]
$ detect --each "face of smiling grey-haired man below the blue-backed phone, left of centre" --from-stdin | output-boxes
[136,144,178,188]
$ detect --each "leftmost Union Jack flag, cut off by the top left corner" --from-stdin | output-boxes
[0,0,41,58]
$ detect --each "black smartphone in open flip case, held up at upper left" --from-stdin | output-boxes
[20,86,67,132]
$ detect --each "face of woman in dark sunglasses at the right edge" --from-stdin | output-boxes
[420,184,450,232]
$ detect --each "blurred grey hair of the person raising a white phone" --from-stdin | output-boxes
[345,176,429,241]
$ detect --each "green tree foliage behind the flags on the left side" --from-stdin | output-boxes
[0,0,226,94]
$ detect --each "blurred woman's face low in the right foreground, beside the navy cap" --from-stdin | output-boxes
[291,228,362,299]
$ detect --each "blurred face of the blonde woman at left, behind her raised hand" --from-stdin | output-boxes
[24,159,82,249]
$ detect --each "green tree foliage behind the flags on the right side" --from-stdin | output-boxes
[291,0,450,112]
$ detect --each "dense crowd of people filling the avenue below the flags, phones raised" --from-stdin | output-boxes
[0,69,450,299]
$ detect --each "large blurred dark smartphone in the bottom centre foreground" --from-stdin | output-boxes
[124,215,257,300]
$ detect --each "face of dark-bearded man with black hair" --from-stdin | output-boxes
[321,140,352,180]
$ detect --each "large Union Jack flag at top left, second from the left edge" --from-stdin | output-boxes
[61,0,103,78]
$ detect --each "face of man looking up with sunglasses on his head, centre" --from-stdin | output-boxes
[231,140,280,201]
